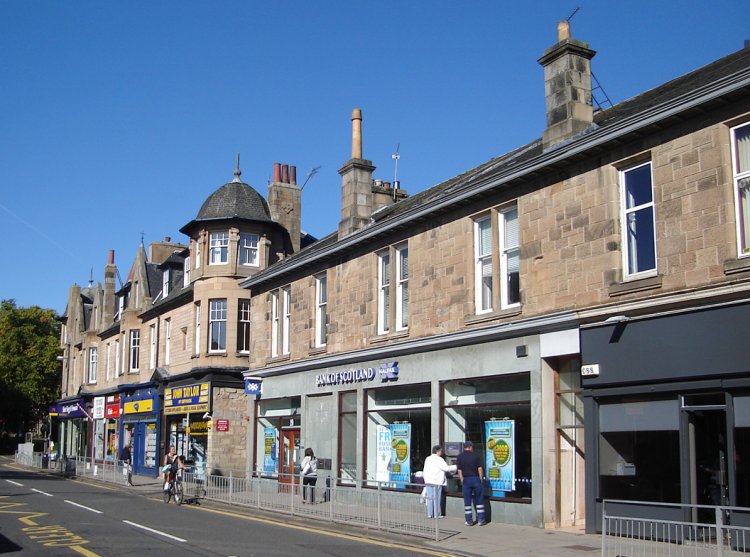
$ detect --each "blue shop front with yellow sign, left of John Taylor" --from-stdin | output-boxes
[120,386,160,476]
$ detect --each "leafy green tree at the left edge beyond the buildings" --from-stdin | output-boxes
[0,300,60,433]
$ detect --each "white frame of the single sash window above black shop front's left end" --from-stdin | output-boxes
[619,161,658,280]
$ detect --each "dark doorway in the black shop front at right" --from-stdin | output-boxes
[688,409,730,522]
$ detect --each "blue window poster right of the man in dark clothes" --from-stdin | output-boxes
[484,420,516,497]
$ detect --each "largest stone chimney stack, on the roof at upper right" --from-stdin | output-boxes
[539,21,596,150]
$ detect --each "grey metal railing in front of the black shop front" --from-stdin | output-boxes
[602,500,750,557]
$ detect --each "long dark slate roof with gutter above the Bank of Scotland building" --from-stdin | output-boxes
[241,47,750,287]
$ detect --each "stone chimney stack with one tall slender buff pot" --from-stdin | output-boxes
[339,108,375,238]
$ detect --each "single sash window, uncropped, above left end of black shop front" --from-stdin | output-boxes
[620,162,656,278]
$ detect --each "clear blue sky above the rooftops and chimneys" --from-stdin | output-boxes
[0,0,750,313]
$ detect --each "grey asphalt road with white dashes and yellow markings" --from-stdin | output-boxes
[0,465,446,557]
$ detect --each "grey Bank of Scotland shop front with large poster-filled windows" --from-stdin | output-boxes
[248,330,583,526]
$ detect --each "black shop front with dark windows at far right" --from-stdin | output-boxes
[581,304,750,532]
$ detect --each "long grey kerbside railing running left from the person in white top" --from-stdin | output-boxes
[16,453,446,541]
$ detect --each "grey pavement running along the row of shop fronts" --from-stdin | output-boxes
[3,459,601,557]
